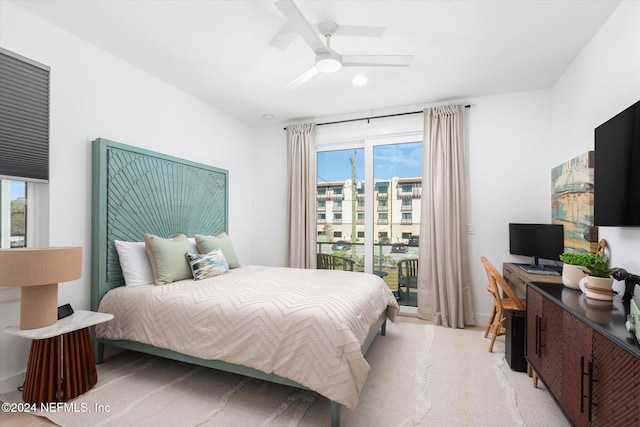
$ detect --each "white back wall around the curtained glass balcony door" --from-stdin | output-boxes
[253,90,556,324]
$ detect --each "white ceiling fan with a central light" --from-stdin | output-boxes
[275,0,413,89]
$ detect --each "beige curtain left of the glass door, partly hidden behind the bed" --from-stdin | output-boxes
[285,123,316,268]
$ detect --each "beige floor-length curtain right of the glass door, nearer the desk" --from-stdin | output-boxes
[418,105,474,328]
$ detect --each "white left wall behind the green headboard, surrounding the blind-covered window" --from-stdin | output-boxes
[0,2,253,392]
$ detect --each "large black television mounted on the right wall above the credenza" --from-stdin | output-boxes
[593,101,640,227]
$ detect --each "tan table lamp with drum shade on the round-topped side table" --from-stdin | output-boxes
[0,247,82,329]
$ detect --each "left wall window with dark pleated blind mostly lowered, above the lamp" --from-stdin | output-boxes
[0,48,49,254]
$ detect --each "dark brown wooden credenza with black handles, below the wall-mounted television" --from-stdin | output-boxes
[527,282,640,426]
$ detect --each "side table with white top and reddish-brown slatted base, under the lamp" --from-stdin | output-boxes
[5,310,113,404]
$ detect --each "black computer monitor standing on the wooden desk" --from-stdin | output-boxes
[509,223,564,272]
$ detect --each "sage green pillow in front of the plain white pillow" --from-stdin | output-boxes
[144,233,192,285]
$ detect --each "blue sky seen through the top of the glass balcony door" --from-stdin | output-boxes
[318,142,422,182]
